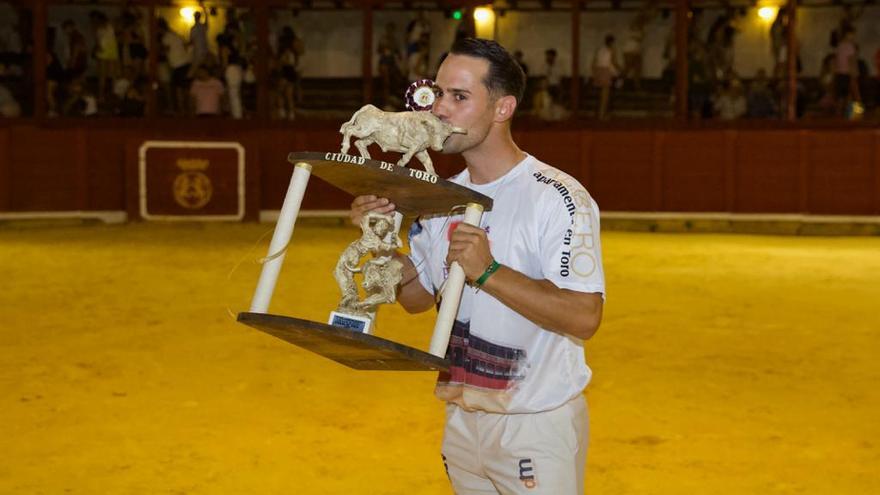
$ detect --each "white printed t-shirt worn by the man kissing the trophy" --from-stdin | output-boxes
[410,156,605,413]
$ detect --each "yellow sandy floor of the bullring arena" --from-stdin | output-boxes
[0,224,880,495]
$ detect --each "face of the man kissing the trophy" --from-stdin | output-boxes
[431,54,495,153]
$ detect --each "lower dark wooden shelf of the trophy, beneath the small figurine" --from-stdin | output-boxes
[238,313,449,371]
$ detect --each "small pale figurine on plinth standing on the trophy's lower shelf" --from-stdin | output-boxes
[329,209,403,333]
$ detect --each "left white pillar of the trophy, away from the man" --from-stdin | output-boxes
[250,162,312,313]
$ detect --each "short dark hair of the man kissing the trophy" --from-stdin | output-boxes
[449,38,526,105]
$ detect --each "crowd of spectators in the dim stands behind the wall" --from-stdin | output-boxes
[0,2,880,121]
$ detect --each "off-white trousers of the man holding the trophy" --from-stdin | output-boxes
[442,396,589,495]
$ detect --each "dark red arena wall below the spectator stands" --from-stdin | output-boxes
[0,121,880,219]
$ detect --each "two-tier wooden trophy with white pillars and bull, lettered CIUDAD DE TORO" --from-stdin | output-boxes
[238,81,492,370]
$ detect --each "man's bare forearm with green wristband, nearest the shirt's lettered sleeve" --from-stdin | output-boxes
[482,266,603,340]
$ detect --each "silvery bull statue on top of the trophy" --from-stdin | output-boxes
[339,105,467,174]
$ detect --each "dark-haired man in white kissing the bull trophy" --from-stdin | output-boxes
[351,38,605,495]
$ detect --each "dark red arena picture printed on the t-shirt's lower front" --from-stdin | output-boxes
[437,320,526,390]
